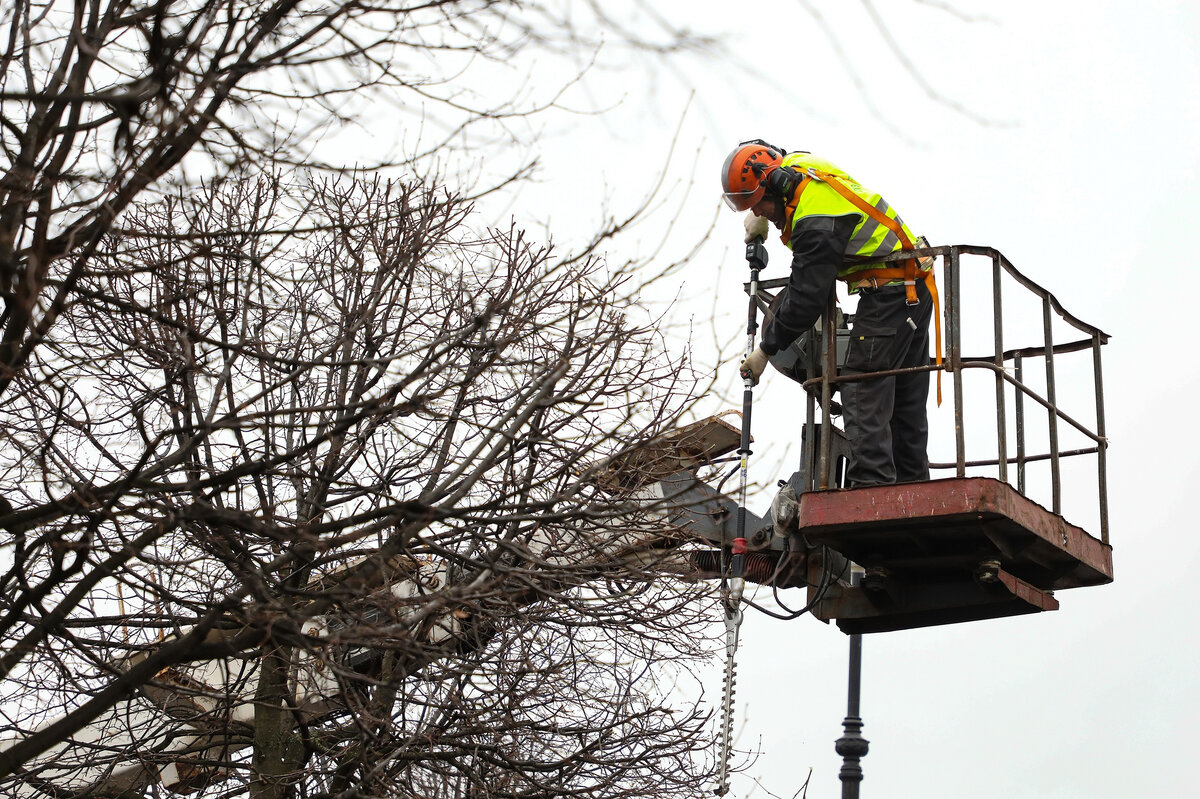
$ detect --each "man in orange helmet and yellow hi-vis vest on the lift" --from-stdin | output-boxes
[721,139,936,487]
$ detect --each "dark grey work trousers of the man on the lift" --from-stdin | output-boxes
[841,283,934,487]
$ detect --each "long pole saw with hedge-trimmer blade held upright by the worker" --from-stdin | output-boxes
[715,226,767,797]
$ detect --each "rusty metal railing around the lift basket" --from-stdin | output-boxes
[758,245,1109,543]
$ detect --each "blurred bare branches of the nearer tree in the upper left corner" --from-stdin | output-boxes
[0,0,703,388]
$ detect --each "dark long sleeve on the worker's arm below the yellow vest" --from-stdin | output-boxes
[762,214,860,355]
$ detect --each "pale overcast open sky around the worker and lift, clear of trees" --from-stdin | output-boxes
[487,0,1200,799]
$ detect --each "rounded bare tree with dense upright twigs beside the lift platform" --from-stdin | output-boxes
[0,169,706,797]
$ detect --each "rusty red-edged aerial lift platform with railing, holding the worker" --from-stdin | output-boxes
[643,246,1112,633]
